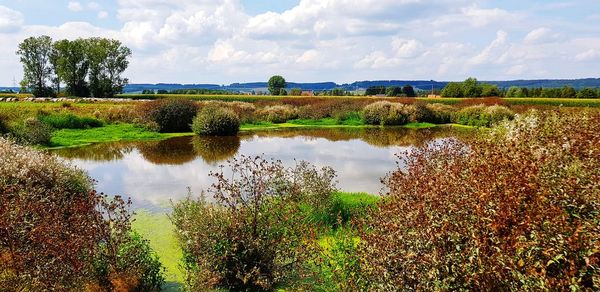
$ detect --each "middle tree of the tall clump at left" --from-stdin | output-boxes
[54,39,90,97]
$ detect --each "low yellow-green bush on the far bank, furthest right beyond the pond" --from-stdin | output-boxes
[454,105,514,127]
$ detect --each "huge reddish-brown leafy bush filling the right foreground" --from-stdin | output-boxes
[359,112,600,291]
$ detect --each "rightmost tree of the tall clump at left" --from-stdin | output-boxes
[88,38,131,97]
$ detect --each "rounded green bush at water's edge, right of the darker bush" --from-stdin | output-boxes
[192,107,240,136]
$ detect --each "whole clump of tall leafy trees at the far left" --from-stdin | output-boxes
[17,36,131,98]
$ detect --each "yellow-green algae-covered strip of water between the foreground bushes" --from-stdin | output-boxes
[132,210,185,283]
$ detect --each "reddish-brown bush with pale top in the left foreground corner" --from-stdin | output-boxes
[0,138,162,291]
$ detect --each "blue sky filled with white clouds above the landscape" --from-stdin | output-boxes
[0,0,600,86]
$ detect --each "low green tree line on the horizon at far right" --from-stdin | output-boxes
[441,77,600,98]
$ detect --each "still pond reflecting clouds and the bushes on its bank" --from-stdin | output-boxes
[54,128,458,211]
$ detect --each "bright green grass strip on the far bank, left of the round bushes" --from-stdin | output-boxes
[50,124,193,148]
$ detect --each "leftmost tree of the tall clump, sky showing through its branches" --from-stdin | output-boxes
[17,36,52,96]
